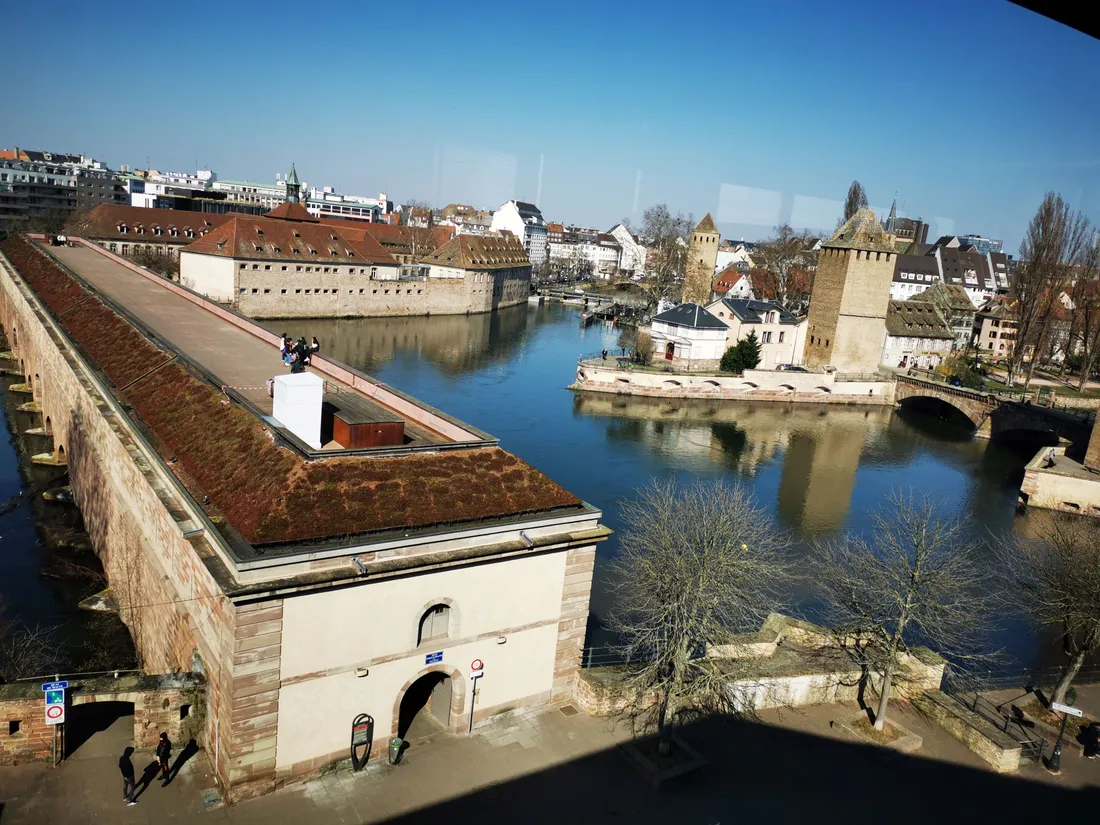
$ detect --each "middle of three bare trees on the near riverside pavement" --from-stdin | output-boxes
[812,491,994,730]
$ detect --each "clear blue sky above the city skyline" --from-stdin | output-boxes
[0,0,1100,252]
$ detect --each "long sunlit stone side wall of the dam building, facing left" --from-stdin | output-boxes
[0,256,233,796]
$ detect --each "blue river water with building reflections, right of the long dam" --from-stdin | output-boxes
[277,304,1057,667]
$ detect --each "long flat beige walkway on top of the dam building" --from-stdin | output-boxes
[43,246,449,443]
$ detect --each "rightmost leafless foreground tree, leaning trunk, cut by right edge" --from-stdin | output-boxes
[997,513,1100,702]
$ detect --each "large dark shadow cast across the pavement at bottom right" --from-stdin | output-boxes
[376,721,1100,825]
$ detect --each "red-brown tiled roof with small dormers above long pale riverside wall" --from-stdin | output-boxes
[183,213,397,266]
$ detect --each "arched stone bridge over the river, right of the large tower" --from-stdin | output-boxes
[894,375,1093,451]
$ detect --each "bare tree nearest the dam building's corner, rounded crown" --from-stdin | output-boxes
[609,481,787,754]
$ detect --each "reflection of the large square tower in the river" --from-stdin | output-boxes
[779,413,870,536]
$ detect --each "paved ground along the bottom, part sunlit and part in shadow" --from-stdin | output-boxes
[0,705,1100,825]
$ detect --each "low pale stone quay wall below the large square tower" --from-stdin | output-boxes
[569,358,894,407]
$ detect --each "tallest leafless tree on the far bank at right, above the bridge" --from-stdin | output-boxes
[1008,191,1091,388]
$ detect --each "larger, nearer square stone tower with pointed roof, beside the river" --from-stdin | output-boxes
[804,209,898,373]
